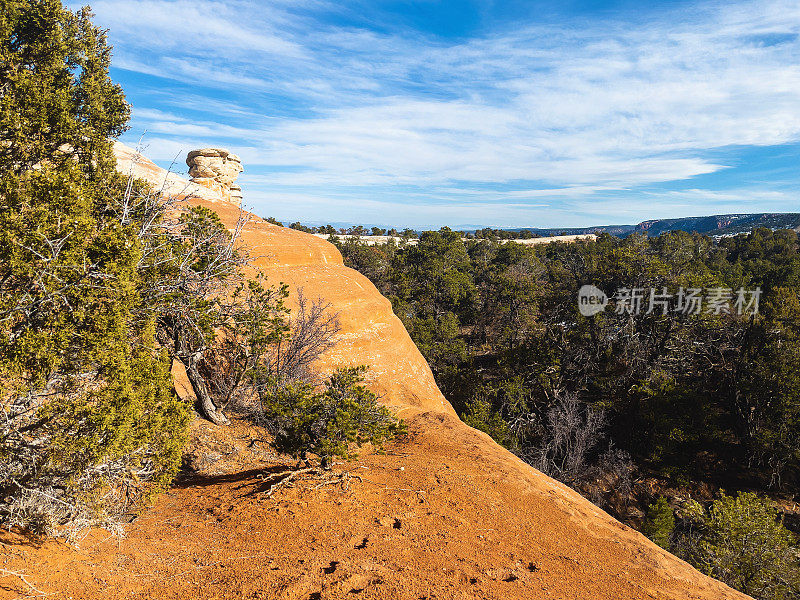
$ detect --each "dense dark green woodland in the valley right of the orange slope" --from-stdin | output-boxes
[339,228,800,598]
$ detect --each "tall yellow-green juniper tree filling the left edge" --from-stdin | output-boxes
[0,0,190,532]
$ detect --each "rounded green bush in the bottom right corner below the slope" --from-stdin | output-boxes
[689,492,800,600]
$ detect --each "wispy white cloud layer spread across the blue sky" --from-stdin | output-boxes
[89,0,800,225]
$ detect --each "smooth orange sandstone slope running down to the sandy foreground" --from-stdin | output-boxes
[0,145,747,600]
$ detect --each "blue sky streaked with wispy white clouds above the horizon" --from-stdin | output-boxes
[72,0,800,227]
